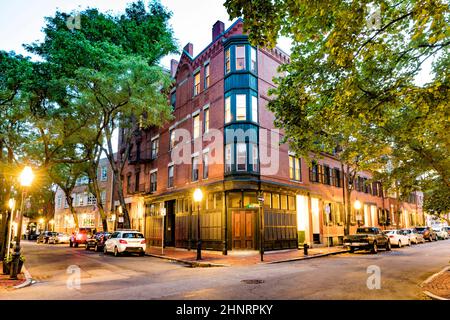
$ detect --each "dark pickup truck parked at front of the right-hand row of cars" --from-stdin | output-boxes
[344,227,391,253]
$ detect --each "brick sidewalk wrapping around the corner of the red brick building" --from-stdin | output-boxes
[146,247,347,267]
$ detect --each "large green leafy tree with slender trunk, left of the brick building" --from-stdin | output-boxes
[23,1,176,227]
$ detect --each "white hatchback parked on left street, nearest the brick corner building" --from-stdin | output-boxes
[103,230,147,257]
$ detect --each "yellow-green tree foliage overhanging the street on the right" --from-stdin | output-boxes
[225,0,450,218]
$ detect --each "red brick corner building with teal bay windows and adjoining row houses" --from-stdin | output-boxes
[119,19,423,253]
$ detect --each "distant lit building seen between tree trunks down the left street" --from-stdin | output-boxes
[54,158,115,233]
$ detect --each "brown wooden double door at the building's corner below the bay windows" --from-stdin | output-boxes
[232,210,255,249]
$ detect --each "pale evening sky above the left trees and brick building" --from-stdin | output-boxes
[0,0,290,68]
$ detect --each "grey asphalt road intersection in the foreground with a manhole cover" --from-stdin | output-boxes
[0,240,450,300]
